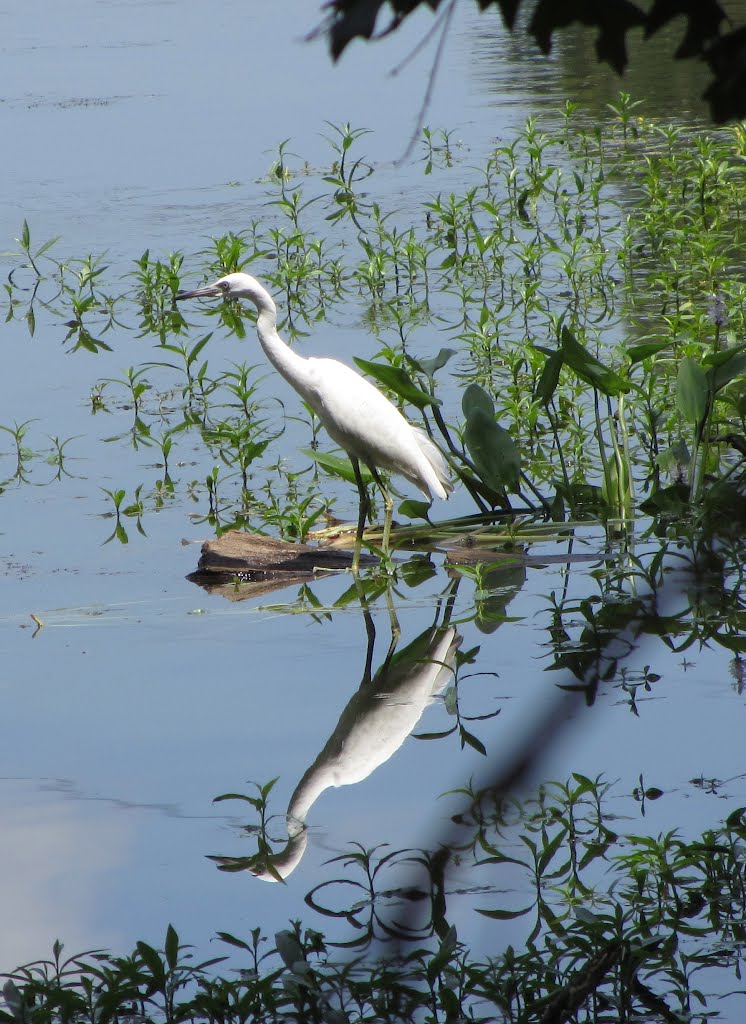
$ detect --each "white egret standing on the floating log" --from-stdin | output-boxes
[176,273,453,570]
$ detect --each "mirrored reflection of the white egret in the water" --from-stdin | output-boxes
[211,592,462,882]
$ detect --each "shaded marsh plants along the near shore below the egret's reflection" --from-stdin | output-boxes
[0,774,746,1024]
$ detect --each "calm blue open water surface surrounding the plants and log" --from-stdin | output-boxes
[0,0,746,1003]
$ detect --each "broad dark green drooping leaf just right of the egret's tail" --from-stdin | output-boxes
[462,384,521,492]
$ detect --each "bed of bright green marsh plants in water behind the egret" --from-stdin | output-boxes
[5,100,746,537]
